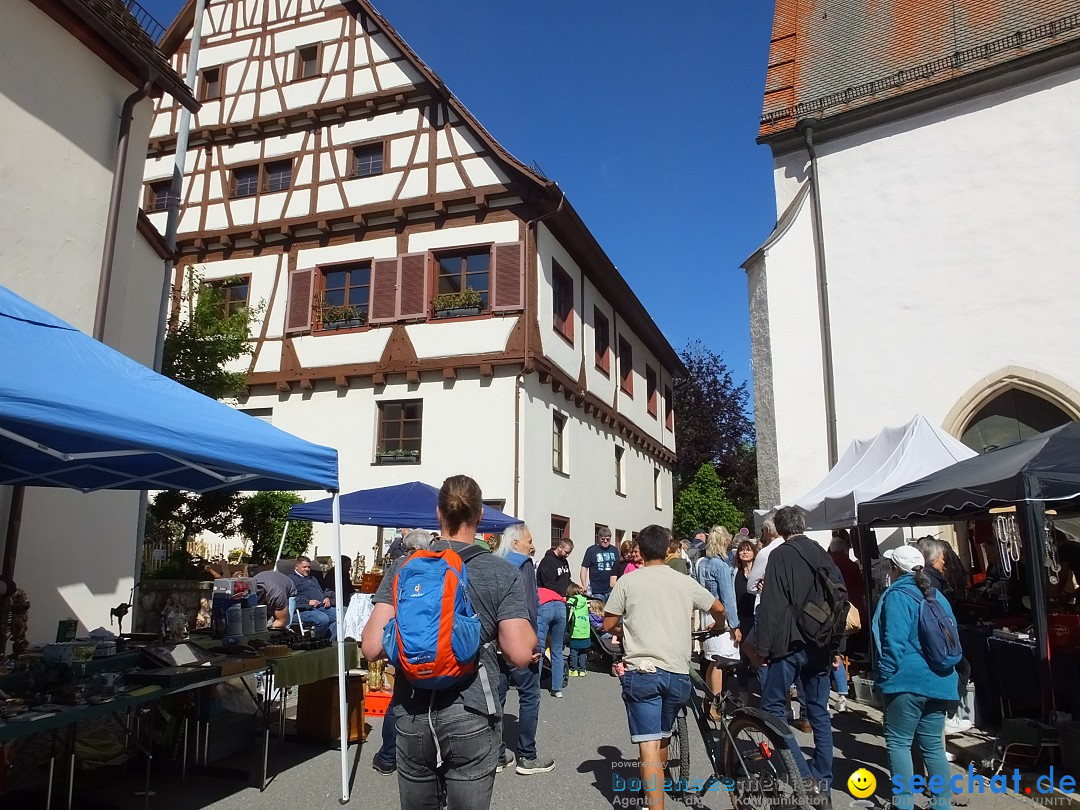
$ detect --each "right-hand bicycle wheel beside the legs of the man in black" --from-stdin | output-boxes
[724,717,808,810]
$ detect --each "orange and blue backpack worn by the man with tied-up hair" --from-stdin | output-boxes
[382,545,488,690]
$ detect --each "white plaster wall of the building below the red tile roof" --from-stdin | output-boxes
[767,68,1080,500]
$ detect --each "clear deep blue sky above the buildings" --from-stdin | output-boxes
[140,0,775,393]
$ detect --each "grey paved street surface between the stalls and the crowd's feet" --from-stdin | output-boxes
[95,673,1034,810]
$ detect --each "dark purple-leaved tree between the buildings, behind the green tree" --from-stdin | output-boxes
[672,340,758,525]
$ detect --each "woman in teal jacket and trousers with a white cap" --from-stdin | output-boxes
[873,545,957,810]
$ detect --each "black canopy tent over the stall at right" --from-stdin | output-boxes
[859,422,1080,717]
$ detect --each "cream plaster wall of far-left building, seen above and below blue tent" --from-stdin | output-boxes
[0,2,161,640]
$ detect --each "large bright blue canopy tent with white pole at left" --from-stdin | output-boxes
[0,286,358,801]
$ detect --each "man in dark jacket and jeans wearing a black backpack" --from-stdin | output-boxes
[743,507,848,807]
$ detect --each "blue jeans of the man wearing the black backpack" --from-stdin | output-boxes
[760,647,833,785]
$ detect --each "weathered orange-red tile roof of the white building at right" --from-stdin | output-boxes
[759,0,1080,138]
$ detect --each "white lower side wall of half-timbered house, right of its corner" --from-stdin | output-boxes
[521,377,672,579]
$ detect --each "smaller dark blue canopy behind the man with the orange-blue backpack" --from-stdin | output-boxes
[287,481,524,533]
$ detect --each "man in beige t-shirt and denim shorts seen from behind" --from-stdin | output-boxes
[604,525,726,808]
